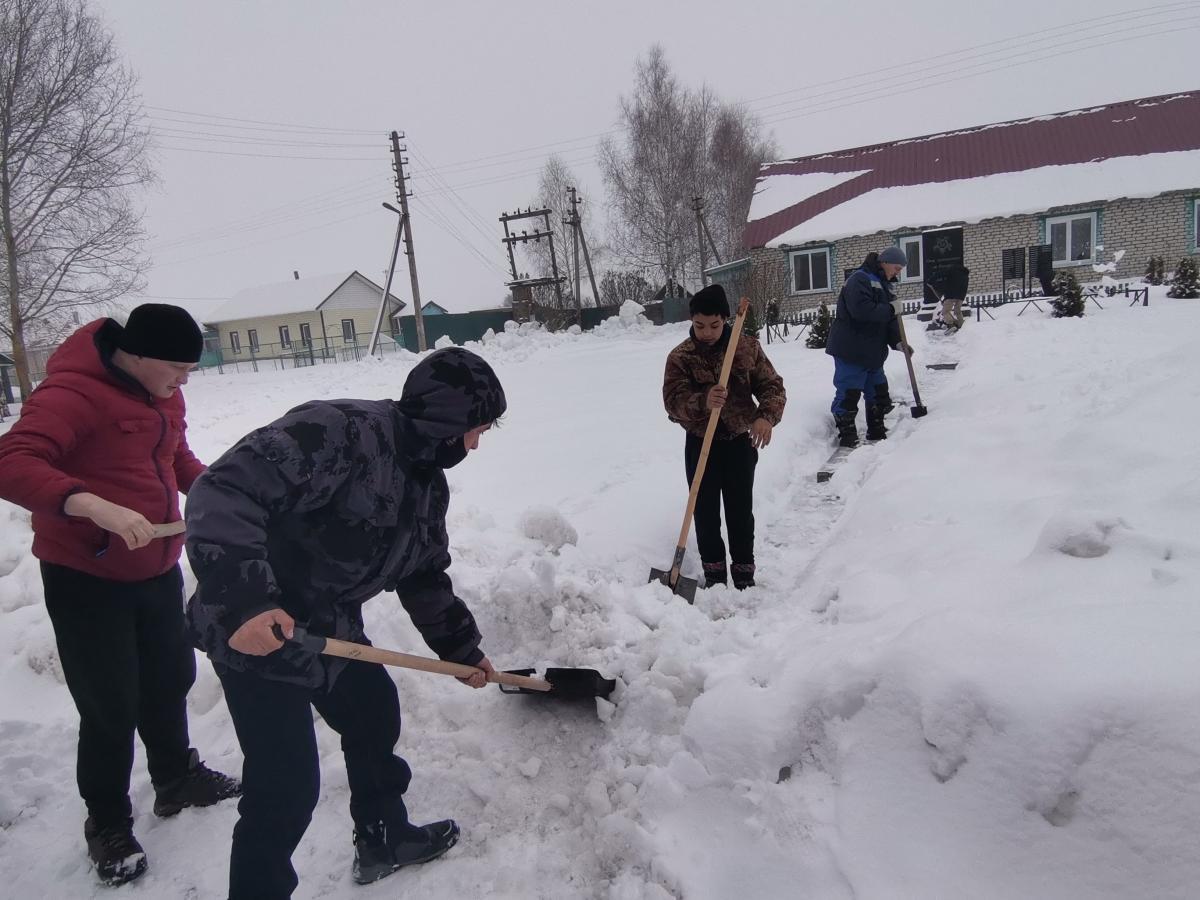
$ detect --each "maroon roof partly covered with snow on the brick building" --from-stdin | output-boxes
[743,92,1200,248]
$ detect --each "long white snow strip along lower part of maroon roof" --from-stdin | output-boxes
[751,150,1200,247]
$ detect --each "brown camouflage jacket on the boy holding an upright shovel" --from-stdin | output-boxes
[662,325,787,440]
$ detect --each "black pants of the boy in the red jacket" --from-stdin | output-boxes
[42,563,196,824]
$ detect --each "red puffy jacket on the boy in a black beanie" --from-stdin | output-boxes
[0,319,204,581]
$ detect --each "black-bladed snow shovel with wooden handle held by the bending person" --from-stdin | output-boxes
[272,625,617,700]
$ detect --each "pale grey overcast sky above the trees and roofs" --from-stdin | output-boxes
[96,0,1200,319]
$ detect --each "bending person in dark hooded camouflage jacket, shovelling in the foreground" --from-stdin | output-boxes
[187,348,506,900]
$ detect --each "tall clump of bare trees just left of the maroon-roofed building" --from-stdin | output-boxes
[600,44,774,287]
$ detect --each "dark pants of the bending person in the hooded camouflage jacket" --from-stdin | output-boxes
[217,661,413,900]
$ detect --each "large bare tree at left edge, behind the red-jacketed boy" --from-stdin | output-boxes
[0,0,154,396]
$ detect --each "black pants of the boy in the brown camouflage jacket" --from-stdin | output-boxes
[683,434,758,565]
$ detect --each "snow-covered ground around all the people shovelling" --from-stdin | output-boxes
[0,292,1200,900]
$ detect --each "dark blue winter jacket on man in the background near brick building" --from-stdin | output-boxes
[826,265,900,368]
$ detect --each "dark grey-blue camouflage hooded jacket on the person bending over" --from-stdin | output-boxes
[187,348,505,688]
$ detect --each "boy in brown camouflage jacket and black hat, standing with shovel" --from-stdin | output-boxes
[662,284,787,590]
